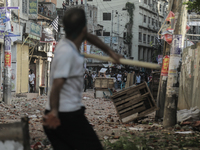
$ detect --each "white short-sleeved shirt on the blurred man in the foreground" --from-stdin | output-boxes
[46,38,84,112]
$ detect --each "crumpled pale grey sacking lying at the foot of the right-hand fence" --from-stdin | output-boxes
[177,107,200,122]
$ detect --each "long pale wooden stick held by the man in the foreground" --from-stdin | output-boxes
[83,53,161,70]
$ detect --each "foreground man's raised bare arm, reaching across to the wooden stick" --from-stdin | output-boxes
[86,33,123,63]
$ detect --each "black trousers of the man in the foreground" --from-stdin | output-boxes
[44,107,103,150]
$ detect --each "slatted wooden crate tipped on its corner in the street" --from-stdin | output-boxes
[111,82,158,123]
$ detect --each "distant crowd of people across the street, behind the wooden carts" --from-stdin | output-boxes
[84,68,152,92]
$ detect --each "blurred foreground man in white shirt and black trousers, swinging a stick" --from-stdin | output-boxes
[43,8,120,150]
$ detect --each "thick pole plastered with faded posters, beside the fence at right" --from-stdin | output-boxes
[163,0,188,127]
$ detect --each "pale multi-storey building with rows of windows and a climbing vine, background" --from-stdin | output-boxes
[88,0,167,62]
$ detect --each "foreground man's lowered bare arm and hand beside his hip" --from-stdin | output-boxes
[43,78,66,129]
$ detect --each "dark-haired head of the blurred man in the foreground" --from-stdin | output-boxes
[63,8,87,39]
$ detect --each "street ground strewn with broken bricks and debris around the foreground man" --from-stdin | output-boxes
[0,90,200,150]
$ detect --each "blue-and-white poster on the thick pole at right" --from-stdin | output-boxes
[170,35,182,55]
